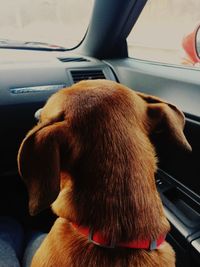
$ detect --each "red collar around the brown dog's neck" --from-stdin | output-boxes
[71,222,165,250]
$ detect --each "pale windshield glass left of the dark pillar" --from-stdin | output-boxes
[0,0,93,48]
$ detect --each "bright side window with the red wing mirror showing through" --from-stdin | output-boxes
[128,0,200,67]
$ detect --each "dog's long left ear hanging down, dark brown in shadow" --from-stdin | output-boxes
[18,122,63,215]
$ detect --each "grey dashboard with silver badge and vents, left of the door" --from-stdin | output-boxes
[0,49,116,175]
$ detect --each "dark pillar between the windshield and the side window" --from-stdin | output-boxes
[77,0,147,59]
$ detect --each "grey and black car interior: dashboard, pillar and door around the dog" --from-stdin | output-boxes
[0,0,200,267]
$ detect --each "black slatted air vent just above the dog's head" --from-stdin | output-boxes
[71,70,106,83]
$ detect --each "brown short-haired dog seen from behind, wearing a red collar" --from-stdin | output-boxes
[18,80,191,267]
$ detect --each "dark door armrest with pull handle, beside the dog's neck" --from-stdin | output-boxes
[156,169,200,242]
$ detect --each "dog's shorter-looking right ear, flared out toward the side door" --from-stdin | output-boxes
[137,92,192,151]
